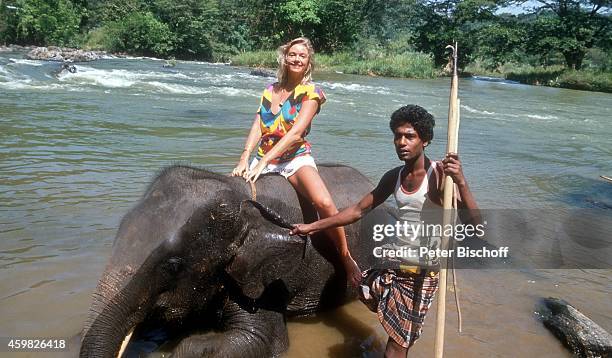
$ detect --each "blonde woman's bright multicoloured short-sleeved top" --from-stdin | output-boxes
[257,83,325,164]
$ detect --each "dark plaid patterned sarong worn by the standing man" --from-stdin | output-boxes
[358,269,439,348]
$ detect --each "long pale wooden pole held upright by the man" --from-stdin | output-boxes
[434,42,459,358]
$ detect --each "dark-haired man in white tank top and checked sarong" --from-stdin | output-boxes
[291,105,481,357]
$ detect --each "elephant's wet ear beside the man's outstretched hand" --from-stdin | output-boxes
[226,201,306,299]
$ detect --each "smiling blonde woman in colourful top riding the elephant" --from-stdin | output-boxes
[232,37,361,286]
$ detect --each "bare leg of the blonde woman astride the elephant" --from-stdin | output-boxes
[287,166,361,286]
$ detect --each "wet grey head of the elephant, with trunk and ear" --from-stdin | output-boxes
[81,167,304,357]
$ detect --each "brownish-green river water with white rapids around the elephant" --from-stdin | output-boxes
[0,52,612,357]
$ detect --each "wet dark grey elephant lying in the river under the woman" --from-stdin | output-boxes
[80,165,389,357]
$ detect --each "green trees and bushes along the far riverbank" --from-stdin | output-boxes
[0,0,612,92]
